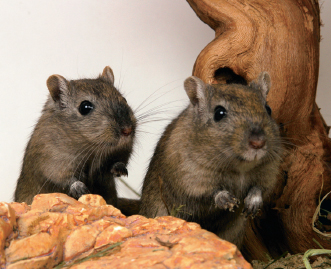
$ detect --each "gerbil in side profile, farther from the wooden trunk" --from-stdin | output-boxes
[14,66,136,206]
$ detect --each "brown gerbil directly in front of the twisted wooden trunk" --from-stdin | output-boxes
[140,72,282,248]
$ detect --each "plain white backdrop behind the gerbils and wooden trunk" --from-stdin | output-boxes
[0,0,331,202]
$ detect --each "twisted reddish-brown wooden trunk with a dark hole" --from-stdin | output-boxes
[187,0,331,260]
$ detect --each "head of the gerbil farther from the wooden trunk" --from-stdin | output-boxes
[44,66,136,152]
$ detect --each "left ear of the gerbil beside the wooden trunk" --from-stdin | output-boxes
[184,76,206,112]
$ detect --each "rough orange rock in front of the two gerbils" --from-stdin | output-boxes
[0,193,251,269]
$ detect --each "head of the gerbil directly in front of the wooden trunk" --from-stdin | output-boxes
[184,72,281,169]
